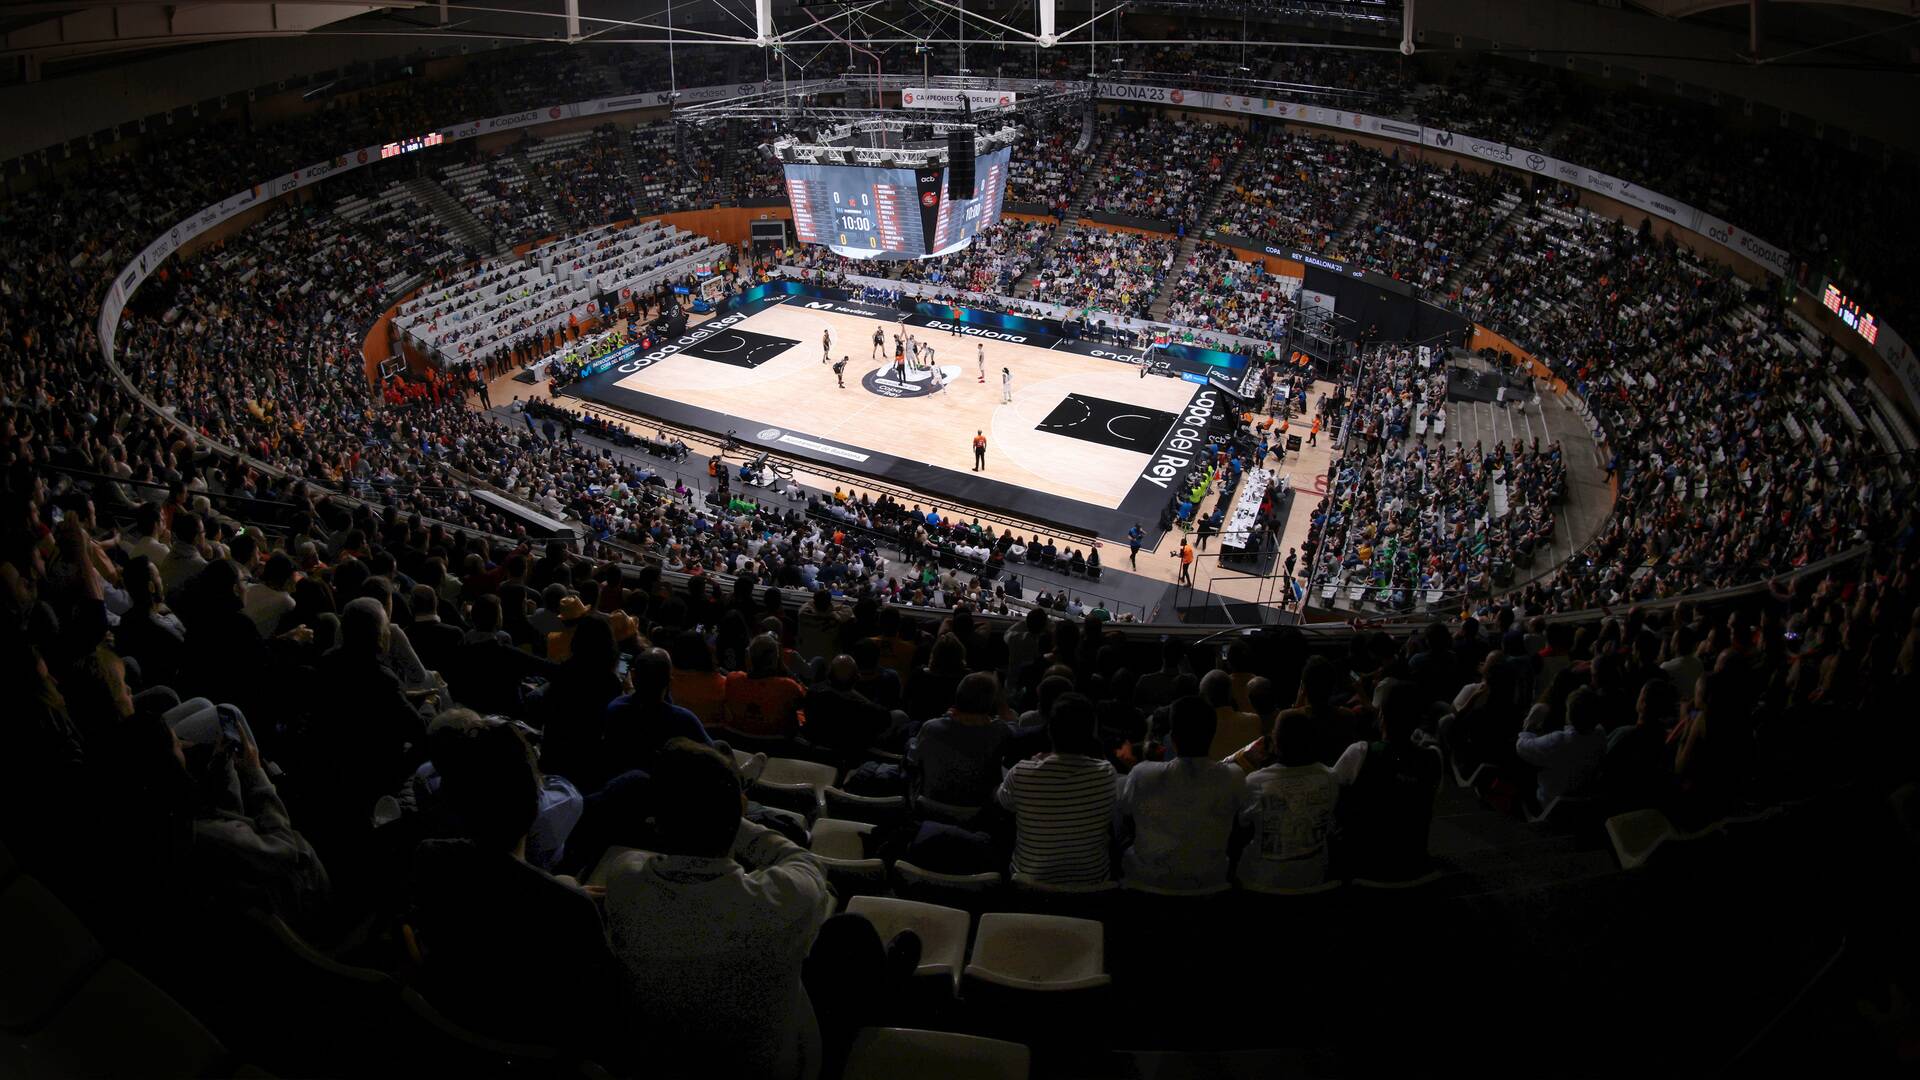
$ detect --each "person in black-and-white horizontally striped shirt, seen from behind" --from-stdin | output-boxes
[996,694,1116,886]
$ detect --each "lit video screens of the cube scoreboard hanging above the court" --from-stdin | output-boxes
[785,146,1012,259]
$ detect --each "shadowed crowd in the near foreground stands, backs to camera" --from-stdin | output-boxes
[0,426,1920,1076]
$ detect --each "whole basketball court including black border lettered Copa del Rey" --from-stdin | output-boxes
[563,296,1233,540]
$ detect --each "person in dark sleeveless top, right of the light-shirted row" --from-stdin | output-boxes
[1336,680,1440,882]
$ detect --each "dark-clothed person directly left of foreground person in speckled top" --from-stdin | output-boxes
[411,721,616,1053]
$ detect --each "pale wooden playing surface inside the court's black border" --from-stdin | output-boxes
[620,295,1196,511]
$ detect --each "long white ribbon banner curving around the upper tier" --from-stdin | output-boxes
[100,75,1920,417]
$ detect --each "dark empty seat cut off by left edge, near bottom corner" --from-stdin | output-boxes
[0,874,106,1032]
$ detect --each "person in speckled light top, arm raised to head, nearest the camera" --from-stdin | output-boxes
[607,740,833,1076]
